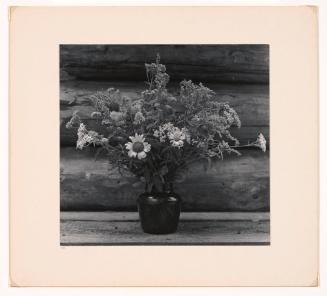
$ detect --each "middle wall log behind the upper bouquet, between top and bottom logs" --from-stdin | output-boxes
[60,81,269,146]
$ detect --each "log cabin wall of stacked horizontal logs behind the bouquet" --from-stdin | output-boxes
[60,45,269,211]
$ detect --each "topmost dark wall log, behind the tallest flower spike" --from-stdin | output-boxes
[60,45,269,83]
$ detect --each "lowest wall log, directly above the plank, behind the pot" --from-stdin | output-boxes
[60,148,269,211]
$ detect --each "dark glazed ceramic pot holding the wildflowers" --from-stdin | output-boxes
[137,192,181,234]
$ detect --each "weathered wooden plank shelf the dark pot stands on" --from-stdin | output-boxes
[60,213,270,246]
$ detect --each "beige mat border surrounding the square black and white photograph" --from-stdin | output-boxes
[9,7,319,286]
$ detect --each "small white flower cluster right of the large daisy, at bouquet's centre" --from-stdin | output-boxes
[153,122,191,148]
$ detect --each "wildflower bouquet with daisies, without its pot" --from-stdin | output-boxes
[66,55,266,192]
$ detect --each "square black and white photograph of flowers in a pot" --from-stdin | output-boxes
[58,44,270,246]
